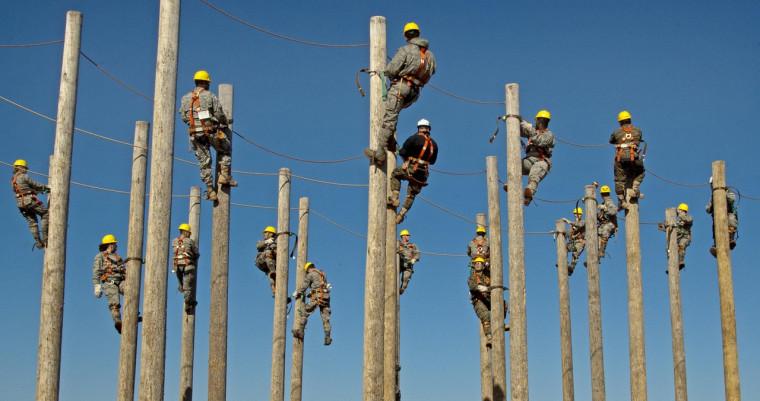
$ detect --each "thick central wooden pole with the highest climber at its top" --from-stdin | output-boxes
[362,16,388,401]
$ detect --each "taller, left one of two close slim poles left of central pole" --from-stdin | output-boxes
[270,168,291,401]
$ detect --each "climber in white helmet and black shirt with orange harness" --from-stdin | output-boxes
[388,118,438,224]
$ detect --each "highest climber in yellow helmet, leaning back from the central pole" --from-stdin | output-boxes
[364,22,436,167]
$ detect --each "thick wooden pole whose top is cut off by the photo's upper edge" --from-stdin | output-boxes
[139,0,180,401]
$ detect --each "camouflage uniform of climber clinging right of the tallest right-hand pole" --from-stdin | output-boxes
[520,121,554,194]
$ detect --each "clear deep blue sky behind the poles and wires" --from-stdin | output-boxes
[0,0,760,401]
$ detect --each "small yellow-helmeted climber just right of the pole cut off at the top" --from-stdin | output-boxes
[172,223,200,314]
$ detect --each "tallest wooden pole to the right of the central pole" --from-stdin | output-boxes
[506,84,528,401]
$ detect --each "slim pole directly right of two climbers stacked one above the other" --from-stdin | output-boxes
[486,156,507,401]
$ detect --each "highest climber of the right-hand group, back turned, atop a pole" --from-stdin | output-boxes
[610,110,644,209]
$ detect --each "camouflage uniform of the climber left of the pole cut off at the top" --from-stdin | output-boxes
[92,248,127,333]
